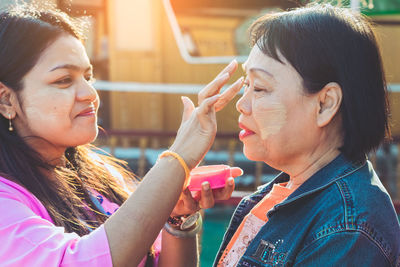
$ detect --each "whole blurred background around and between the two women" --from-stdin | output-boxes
[0,0,400,266]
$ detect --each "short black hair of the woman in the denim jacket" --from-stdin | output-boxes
[249,4,390,161]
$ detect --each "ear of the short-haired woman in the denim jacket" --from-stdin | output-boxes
[317,82,343,127]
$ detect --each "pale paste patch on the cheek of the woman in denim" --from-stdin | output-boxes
[253,99,287,140]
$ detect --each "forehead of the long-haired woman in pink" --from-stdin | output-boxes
[34,35,90,71]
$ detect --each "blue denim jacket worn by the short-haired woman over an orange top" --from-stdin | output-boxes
[214,155,400,267]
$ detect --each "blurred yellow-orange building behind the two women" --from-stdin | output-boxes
[50,0,400,135]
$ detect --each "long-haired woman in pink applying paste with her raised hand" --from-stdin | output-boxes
[0,2,242,267]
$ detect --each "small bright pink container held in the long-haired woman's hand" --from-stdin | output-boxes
[188,165,231,191]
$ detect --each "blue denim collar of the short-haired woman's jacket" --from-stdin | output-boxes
[256,154,366,206]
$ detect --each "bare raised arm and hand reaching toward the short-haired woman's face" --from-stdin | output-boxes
[105,62,243,266]
